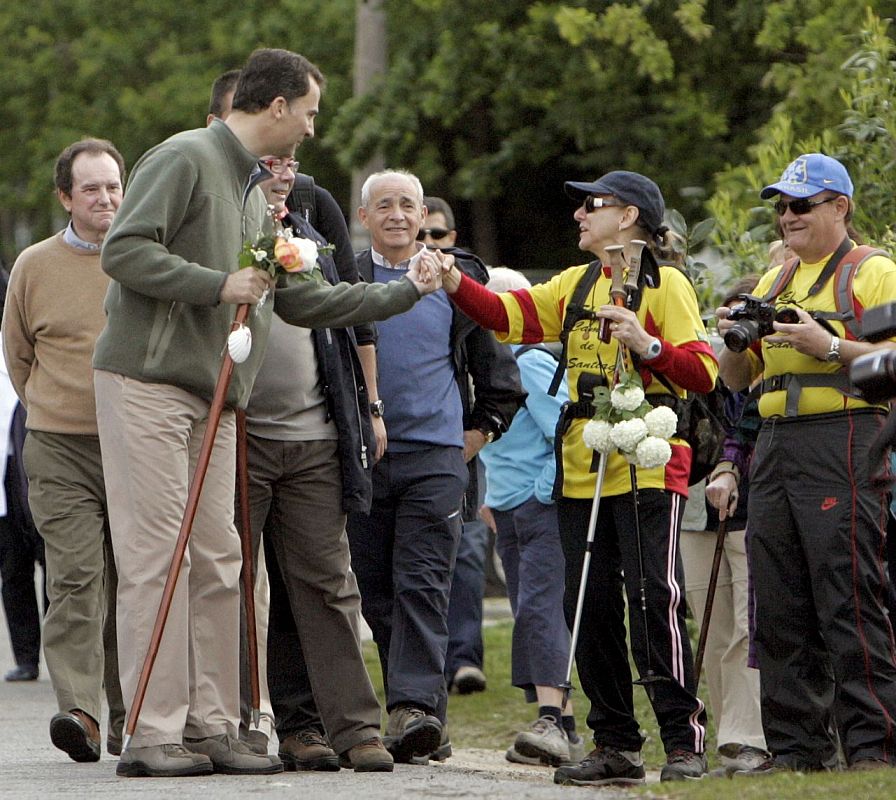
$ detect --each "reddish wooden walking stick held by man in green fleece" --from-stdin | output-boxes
[122,303,249,752]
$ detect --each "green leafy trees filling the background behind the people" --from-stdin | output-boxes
[0,0,896,310]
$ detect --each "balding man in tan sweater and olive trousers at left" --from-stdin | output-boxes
[3,139,124,761]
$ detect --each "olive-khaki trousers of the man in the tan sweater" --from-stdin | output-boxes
[22,431,124,739]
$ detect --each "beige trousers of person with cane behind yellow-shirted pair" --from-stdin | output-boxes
[681,531,765,750]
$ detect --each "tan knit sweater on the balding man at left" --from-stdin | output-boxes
[3,232,109,435]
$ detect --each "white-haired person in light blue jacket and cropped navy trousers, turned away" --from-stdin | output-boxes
[479,267,584,766]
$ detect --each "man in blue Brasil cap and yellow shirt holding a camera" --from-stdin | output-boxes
[716,153,896,774]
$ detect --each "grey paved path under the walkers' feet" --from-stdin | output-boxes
[0,592,644,800]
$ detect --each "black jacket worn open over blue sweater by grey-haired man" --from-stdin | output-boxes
[356,247,526,521]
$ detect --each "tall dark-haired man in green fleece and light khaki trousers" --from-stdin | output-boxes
[94,50,439,777]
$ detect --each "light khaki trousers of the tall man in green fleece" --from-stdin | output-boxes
[94,370,241,747]
